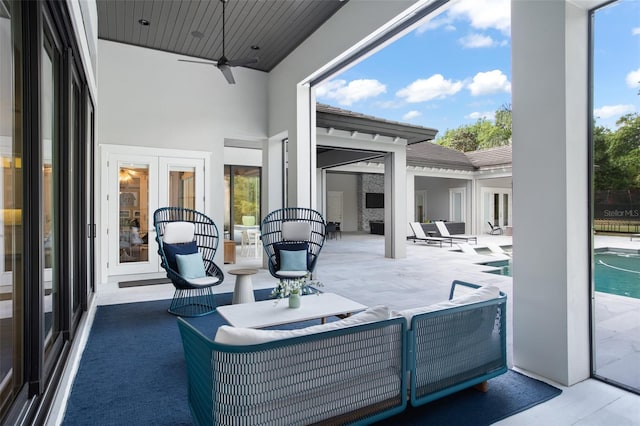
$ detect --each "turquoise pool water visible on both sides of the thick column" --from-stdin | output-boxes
[484,251,640,299]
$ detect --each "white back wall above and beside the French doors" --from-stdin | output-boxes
[97,40,268,276]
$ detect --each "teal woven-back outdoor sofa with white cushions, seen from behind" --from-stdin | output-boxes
[178,281,507,425]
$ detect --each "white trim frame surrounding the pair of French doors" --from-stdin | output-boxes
[96,144,212,283]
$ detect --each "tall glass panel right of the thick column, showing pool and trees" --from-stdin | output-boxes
[589,0,640,393]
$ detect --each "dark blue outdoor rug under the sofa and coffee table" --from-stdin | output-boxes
[62,290,561,426]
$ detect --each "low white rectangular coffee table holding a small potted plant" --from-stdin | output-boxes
[217,293,367,328]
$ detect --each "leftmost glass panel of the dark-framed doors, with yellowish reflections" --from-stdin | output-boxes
[0,1,23,415]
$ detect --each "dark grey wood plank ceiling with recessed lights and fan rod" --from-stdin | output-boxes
[97,0,346,72]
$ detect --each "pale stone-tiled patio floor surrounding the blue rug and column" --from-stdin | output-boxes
[86,233,640,425]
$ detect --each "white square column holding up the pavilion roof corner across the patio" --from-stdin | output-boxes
[384,149,407,259]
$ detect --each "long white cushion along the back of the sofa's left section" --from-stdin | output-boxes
[214,306,391,345]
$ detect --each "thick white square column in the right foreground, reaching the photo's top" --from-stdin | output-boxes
[511,0,590,385]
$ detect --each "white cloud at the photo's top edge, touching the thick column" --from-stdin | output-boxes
[447,0,511,34]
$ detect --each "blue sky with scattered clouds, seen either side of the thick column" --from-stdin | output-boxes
[316,0,640,136]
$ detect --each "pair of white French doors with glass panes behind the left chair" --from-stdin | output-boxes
[105,148,205,275]
